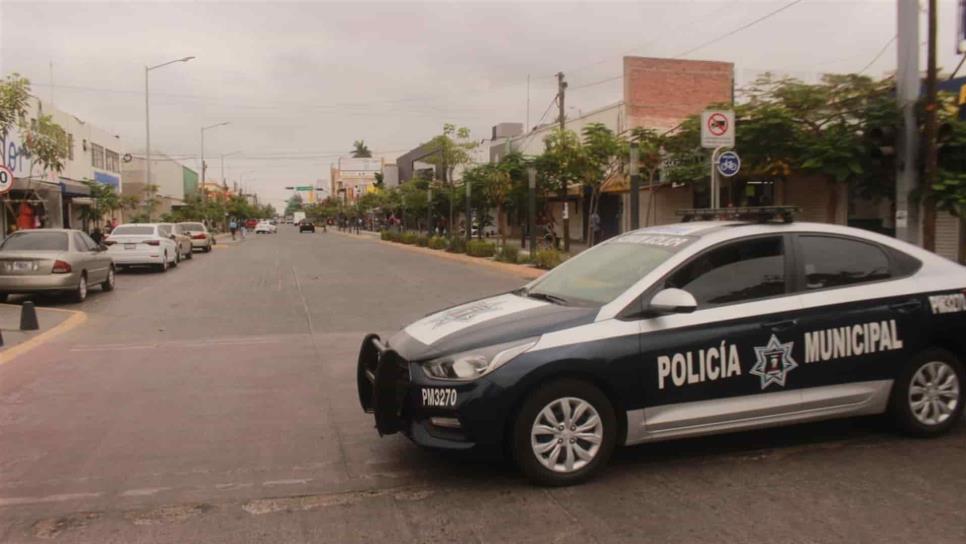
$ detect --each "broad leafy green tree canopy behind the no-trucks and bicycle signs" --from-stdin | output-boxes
[665,74,898,218]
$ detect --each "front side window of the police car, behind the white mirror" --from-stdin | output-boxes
[665,236,785,306]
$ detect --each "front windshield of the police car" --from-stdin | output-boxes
[526,234,694,305]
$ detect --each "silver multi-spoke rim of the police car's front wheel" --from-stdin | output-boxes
[530,397,604,473]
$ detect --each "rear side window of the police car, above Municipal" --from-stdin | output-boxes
[798,236,892,291]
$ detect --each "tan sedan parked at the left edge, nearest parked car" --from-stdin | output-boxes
[0,229,114,302]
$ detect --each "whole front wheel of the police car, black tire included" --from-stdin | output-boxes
[511,379,617,486]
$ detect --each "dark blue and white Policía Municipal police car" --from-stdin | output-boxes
[358,208,966,485]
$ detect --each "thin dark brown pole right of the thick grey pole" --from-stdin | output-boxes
[922,0,939,251]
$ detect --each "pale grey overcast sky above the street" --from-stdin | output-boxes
[0,0,959,210]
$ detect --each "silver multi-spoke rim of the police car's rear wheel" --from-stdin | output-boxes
[909,361,959,427]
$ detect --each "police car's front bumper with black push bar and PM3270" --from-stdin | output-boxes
[356,334,509,450]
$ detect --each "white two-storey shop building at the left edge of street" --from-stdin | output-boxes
[0,98,124,236]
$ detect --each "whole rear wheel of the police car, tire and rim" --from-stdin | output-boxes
[890,348,966,437]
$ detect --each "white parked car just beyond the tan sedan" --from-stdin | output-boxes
[104,223,179,272]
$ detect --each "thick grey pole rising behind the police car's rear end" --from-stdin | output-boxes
[895,0,921,244]
